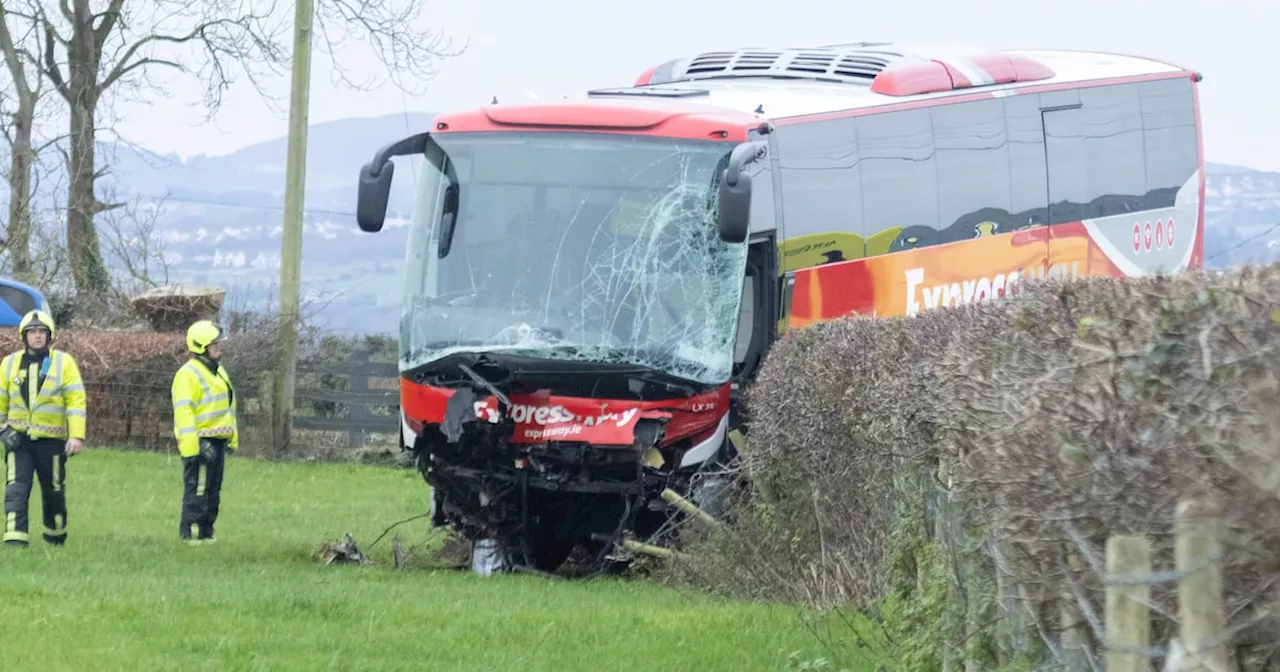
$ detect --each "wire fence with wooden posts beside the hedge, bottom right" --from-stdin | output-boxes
[936,481,1259,672]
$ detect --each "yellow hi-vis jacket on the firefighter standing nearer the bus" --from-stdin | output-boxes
[173,358,239,457]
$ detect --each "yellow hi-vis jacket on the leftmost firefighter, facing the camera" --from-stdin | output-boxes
[0,348,86,440]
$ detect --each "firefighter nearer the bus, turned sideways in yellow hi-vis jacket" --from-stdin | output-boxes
[173,320,239,544]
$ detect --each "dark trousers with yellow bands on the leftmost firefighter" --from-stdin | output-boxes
[4,438,67,545]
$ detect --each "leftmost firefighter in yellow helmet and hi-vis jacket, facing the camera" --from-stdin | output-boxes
[0,310,86,547]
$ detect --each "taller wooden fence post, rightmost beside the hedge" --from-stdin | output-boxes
[1174,498,1231,672]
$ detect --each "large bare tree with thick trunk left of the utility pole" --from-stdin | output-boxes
[29,0,456,300]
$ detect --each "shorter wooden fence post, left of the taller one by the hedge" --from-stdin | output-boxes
[1105,534,1151,672]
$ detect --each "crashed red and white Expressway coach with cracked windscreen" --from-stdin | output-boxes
[357,42,1204,568]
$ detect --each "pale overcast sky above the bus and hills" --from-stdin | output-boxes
[104,0,1280,170]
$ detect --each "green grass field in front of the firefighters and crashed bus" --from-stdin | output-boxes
[0,449,873,672]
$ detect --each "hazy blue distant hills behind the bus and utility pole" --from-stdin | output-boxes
[0,114,1280,332]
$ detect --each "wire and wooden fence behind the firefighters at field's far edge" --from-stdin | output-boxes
[23,332,399,458]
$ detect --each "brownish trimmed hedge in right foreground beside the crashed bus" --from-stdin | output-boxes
[673,268,1280,662]
